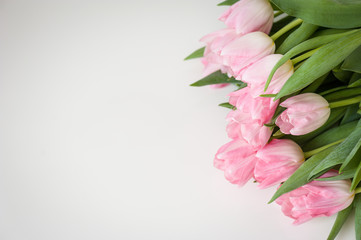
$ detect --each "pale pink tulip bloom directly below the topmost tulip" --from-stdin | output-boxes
[221,32,275,80]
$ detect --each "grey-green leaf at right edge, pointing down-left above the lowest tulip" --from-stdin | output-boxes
[309,126,361,178]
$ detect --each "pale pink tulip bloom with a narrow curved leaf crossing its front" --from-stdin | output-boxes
[242,54,293,96]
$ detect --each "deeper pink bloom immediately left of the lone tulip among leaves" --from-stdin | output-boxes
[229,87,278,124]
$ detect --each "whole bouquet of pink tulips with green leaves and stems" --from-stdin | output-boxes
[186,0,361,239]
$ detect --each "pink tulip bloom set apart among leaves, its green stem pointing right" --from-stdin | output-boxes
[276,93,330,135]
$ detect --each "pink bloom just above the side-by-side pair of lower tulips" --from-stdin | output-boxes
[226,110,272,149]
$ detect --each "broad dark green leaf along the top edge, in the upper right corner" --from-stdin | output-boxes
[272,0,361,29]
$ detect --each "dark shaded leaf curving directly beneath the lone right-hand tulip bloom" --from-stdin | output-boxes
[286,108,346,145]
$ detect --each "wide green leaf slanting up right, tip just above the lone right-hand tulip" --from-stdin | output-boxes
[275,30,361,99]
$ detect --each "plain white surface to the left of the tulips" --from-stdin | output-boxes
[0,0,354,240]
